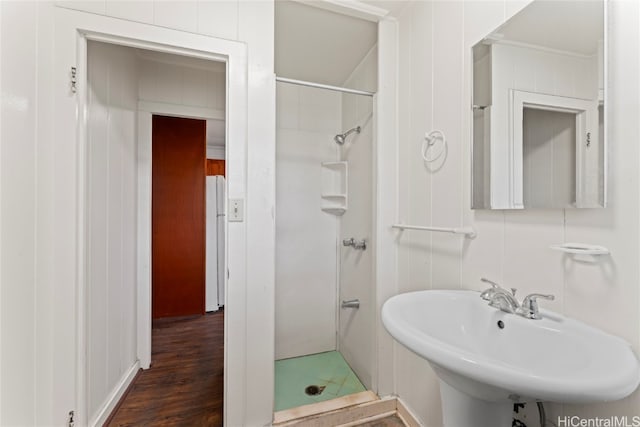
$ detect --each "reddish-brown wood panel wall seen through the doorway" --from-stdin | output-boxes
[151,115,206,319]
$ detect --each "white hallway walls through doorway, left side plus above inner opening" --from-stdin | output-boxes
[87,42,225,424]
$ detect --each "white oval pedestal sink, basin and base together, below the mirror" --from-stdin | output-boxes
[382,290,640,427]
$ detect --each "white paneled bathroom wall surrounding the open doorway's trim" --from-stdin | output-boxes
[0,0,275,425]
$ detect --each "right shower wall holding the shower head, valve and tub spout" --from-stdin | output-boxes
[338,47,378,388]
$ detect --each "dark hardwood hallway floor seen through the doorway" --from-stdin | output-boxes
[106,310,224,426]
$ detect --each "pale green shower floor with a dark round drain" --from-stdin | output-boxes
[274,351,366,412]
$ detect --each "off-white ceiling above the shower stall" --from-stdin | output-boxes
[275,0,378,90]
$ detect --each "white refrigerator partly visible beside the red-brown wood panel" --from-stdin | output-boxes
[205,175,226,311]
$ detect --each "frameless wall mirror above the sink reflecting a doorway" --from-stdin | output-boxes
[471,0,607,209]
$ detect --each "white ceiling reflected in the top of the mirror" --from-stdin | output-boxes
[494,0,604,55]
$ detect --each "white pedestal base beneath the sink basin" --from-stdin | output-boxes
[439,380,513,427]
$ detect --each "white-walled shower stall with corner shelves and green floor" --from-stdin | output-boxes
[274,4,377,412]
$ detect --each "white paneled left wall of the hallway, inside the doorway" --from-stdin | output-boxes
[86,42,138,424]
